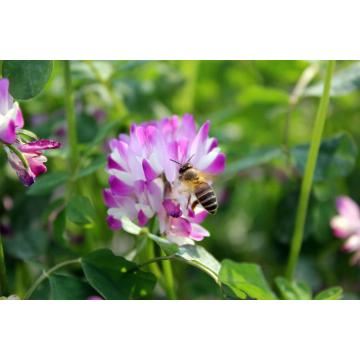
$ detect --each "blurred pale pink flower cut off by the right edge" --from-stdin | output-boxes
[330,196,360,264]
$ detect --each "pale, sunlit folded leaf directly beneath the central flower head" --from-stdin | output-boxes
[175,245,220,282]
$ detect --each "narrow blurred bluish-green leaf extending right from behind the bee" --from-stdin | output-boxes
[224,148,283,176]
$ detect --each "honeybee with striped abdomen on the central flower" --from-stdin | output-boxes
[170,156,218,215]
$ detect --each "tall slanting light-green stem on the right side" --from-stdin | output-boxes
[286,60,335,280]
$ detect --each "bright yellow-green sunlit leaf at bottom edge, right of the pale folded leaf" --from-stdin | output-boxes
[219,260,276,300]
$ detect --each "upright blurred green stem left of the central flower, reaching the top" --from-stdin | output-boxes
[63,60,79,173]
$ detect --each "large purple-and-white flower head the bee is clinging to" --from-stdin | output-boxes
[104,114,225,245]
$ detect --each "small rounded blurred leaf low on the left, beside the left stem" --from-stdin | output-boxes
[66,196,96,226]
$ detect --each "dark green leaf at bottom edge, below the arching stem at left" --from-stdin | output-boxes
[49,274,94,300]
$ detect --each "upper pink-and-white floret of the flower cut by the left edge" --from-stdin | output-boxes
[0,79,24,144]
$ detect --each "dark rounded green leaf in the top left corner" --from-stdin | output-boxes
[2,60,53,100]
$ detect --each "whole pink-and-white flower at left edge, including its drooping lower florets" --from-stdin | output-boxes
[0,79,60,186]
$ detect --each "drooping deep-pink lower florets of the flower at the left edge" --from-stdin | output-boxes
[5,139,60,186]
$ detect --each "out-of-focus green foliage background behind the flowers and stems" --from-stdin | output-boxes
[0,61,360,299]
